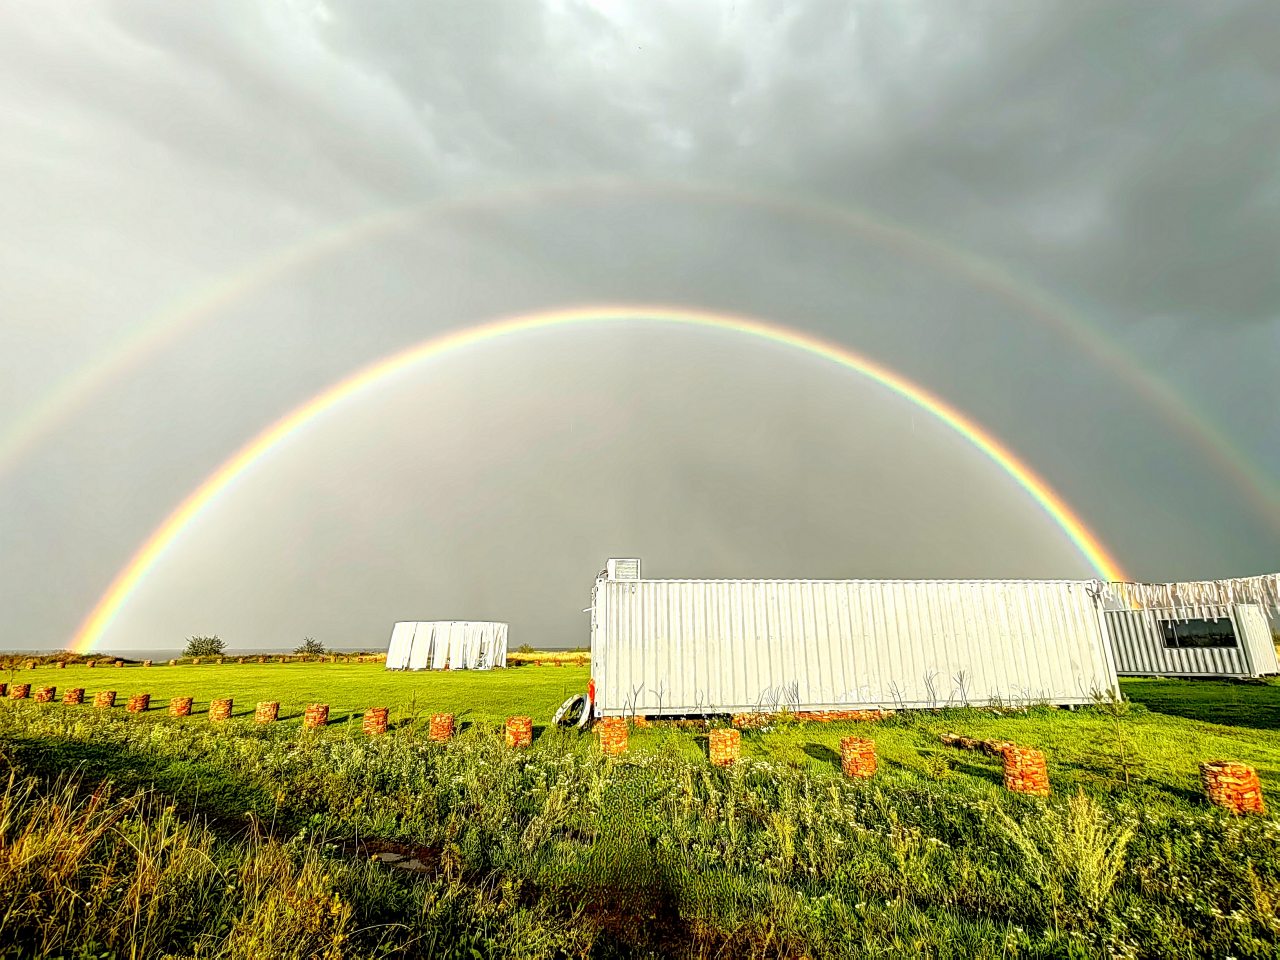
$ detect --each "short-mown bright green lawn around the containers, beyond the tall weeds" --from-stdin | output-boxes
[8,663,1280,803]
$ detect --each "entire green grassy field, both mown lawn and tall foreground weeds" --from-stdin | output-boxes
[0,663,1280,960]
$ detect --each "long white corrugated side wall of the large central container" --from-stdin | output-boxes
[591,579,1116,716]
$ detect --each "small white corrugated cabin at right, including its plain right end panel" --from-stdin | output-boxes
[1106,604,1277,677]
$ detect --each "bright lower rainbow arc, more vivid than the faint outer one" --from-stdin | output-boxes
[70,305,1129,653]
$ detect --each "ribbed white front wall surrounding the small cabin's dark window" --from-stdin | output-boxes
[1105,604,1254,677]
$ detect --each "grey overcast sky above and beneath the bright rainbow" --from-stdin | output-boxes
[0,0,1280,649]
